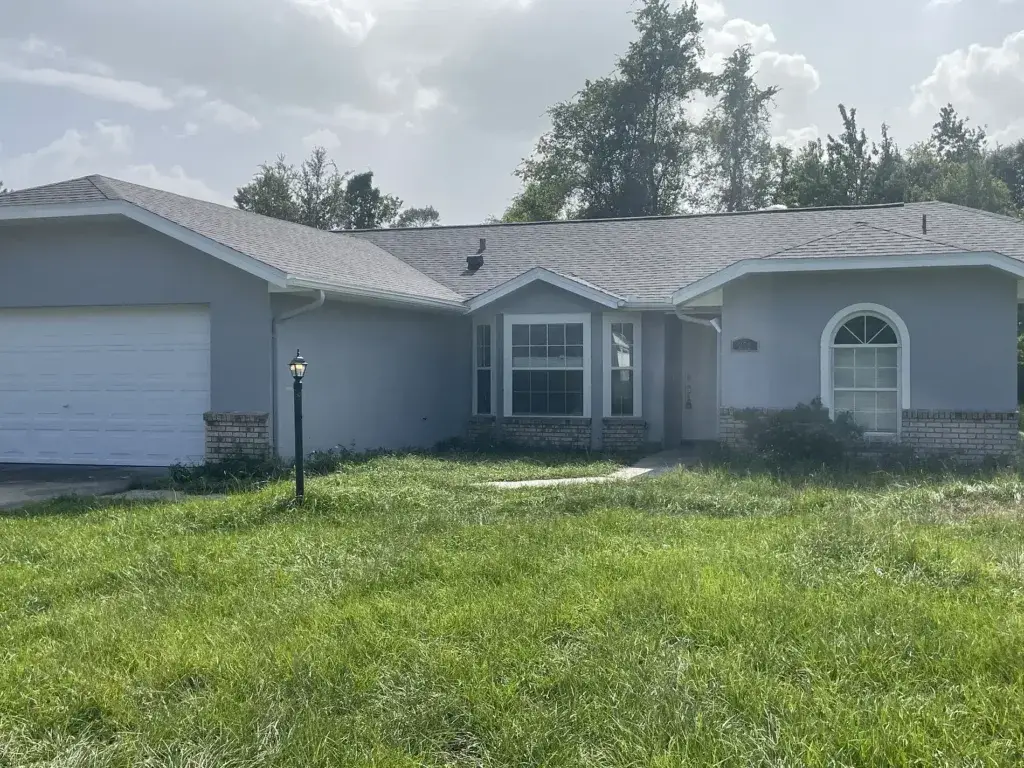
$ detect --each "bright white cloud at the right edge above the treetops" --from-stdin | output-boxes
[910,30,1024,134]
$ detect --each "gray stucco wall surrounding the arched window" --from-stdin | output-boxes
[722,267,1017,412]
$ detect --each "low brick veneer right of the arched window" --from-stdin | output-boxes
[901,411,1019,461]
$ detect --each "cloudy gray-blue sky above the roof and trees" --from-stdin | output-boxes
[0,0,1024,223]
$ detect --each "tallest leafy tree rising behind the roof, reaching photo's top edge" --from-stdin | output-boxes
[506,0,706,218]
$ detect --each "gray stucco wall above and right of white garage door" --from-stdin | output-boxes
[0,217,271,413]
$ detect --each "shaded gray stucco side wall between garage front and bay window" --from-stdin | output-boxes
[271,295,472,457]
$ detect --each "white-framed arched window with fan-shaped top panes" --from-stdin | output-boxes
[821,304,909,435]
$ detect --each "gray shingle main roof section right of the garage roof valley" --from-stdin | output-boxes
[353,203,1024,303]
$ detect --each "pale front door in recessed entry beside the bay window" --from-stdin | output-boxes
[682,323,719,442]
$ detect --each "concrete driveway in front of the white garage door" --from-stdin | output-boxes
[0,464,167,509]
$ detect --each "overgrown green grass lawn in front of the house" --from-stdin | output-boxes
[0,457,1024,768]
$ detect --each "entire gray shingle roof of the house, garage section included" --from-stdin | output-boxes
[0,176,1024,303]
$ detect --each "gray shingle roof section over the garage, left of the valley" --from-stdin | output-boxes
[0,176,462,302]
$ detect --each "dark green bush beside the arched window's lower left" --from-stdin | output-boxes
[742,398,863,467]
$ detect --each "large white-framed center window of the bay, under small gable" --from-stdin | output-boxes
[505,314,590,417]
